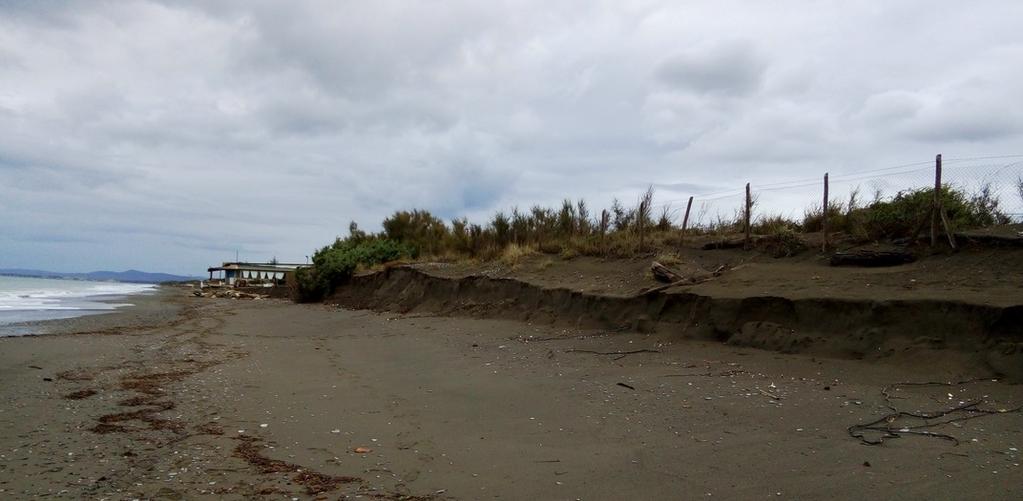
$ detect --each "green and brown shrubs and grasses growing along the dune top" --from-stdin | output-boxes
[297,185,1010,301]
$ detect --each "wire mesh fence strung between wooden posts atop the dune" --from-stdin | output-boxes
[655,154,1023,228]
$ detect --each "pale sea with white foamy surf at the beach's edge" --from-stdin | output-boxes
[0,276,158,336]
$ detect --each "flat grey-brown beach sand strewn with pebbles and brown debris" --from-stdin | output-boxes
[0,287,1023,499]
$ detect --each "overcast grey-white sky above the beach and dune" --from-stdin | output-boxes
[0,0,1023,275]
